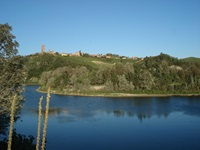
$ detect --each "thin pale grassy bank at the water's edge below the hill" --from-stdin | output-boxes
[37,89,200,97]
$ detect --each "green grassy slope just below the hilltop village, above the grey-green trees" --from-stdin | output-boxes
[22,53,138,84]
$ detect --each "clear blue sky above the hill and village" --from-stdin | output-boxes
[0,0,200,58]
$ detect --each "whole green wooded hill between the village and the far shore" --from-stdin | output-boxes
[22,53,200,94]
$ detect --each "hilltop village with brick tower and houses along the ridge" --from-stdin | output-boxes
[41,45,141,60]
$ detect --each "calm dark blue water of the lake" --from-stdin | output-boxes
[15,86,200,150]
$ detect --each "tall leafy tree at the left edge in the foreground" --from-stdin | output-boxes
[0,24,25,115]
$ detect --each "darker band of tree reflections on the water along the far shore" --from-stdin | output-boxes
[24,95,200,122]
